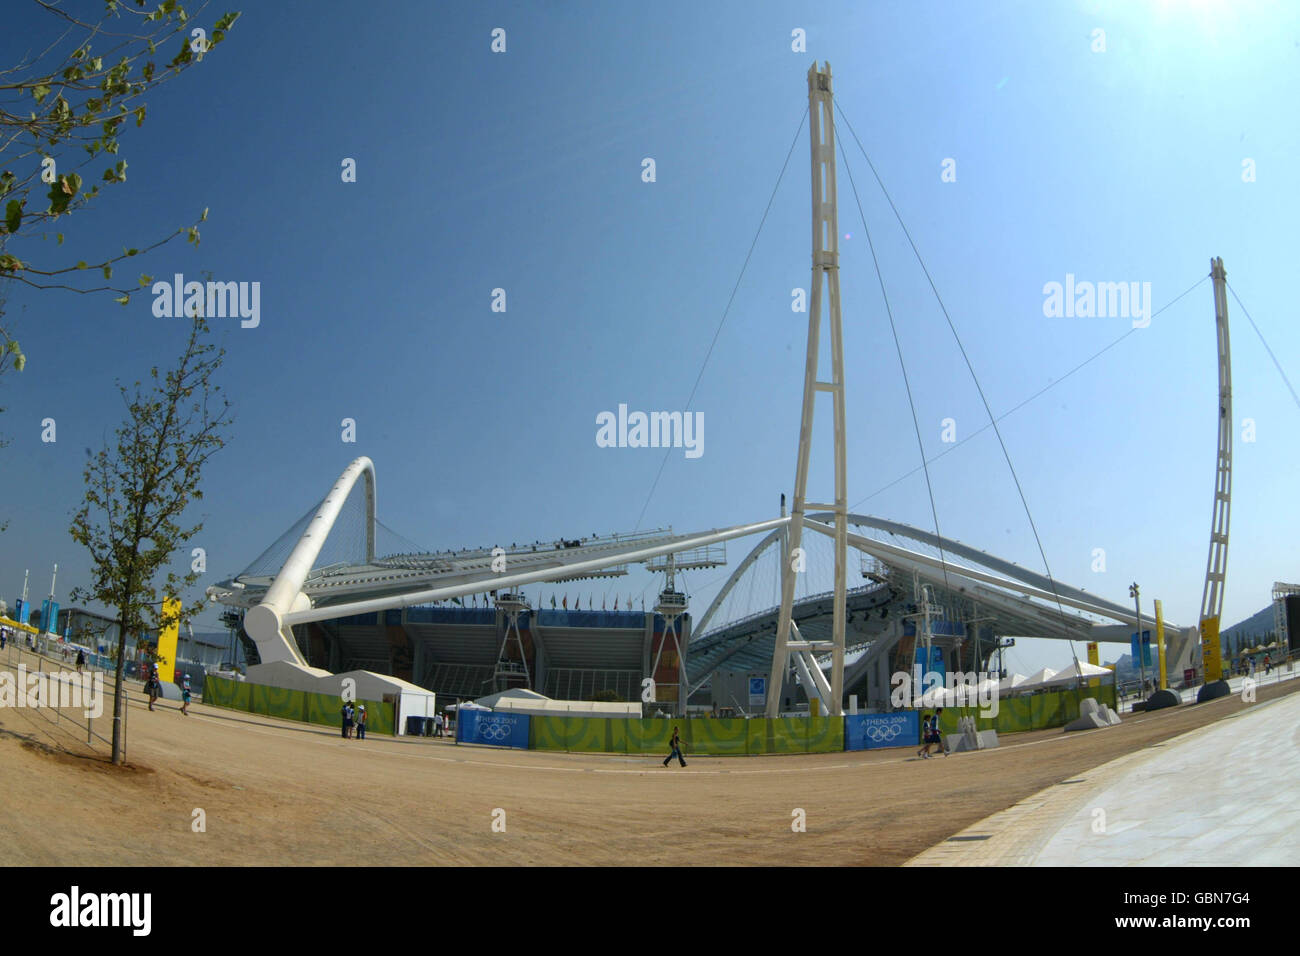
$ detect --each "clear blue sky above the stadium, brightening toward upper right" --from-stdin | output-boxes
[0,3,1300,670]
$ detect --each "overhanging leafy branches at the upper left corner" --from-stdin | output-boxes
[0,0,239,373]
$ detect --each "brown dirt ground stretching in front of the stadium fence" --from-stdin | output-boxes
[0,650,1300,866]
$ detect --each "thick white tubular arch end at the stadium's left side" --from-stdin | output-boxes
[244,455,374,666]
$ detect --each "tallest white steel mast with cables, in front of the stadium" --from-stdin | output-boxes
[766,62,849,717]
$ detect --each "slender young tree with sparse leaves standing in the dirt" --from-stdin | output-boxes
[70,316,230,763]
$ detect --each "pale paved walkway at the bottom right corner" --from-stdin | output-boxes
[907,695,1300,866]
